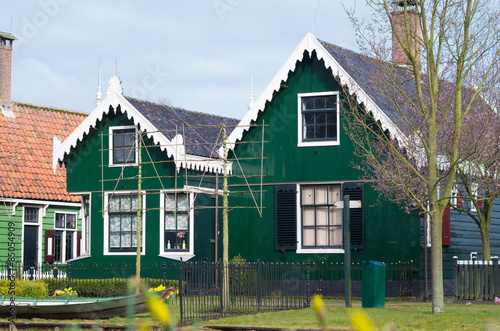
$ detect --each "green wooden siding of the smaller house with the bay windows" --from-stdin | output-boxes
[65,112,219,263]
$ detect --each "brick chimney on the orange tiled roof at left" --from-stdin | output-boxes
[0,32,16,108]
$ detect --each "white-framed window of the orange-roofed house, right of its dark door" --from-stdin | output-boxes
[53,212,78,263]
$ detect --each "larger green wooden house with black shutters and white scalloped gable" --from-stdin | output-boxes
[228,34,421,288]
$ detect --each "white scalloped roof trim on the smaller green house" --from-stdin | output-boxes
[52,82,224,174]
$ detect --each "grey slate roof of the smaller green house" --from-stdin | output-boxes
[126,97,239,158]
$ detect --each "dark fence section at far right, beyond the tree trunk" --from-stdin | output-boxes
[453,256,500,301]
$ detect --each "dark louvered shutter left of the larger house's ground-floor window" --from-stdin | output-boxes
[274,184,297,250]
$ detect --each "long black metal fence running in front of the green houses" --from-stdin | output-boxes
[0,259,413,322]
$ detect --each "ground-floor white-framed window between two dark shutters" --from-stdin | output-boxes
[297,184,344,253]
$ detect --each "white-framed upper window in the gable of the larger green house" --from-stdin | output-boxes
[297,91,340,147]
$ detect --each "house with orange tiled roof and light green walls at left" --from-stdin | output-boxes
[0,33,86,268]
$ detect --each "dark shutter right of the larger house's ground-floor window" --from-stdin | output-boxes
[342,183,365,249]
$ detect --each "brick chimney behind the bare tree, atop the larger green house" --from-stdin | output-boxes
[392,0,422,66]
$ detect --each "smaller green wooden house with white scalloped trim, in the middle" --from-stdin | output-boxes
[54,76,237,264]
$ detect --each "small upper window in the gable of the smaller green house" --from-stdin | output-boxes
[109,126,138,166]
